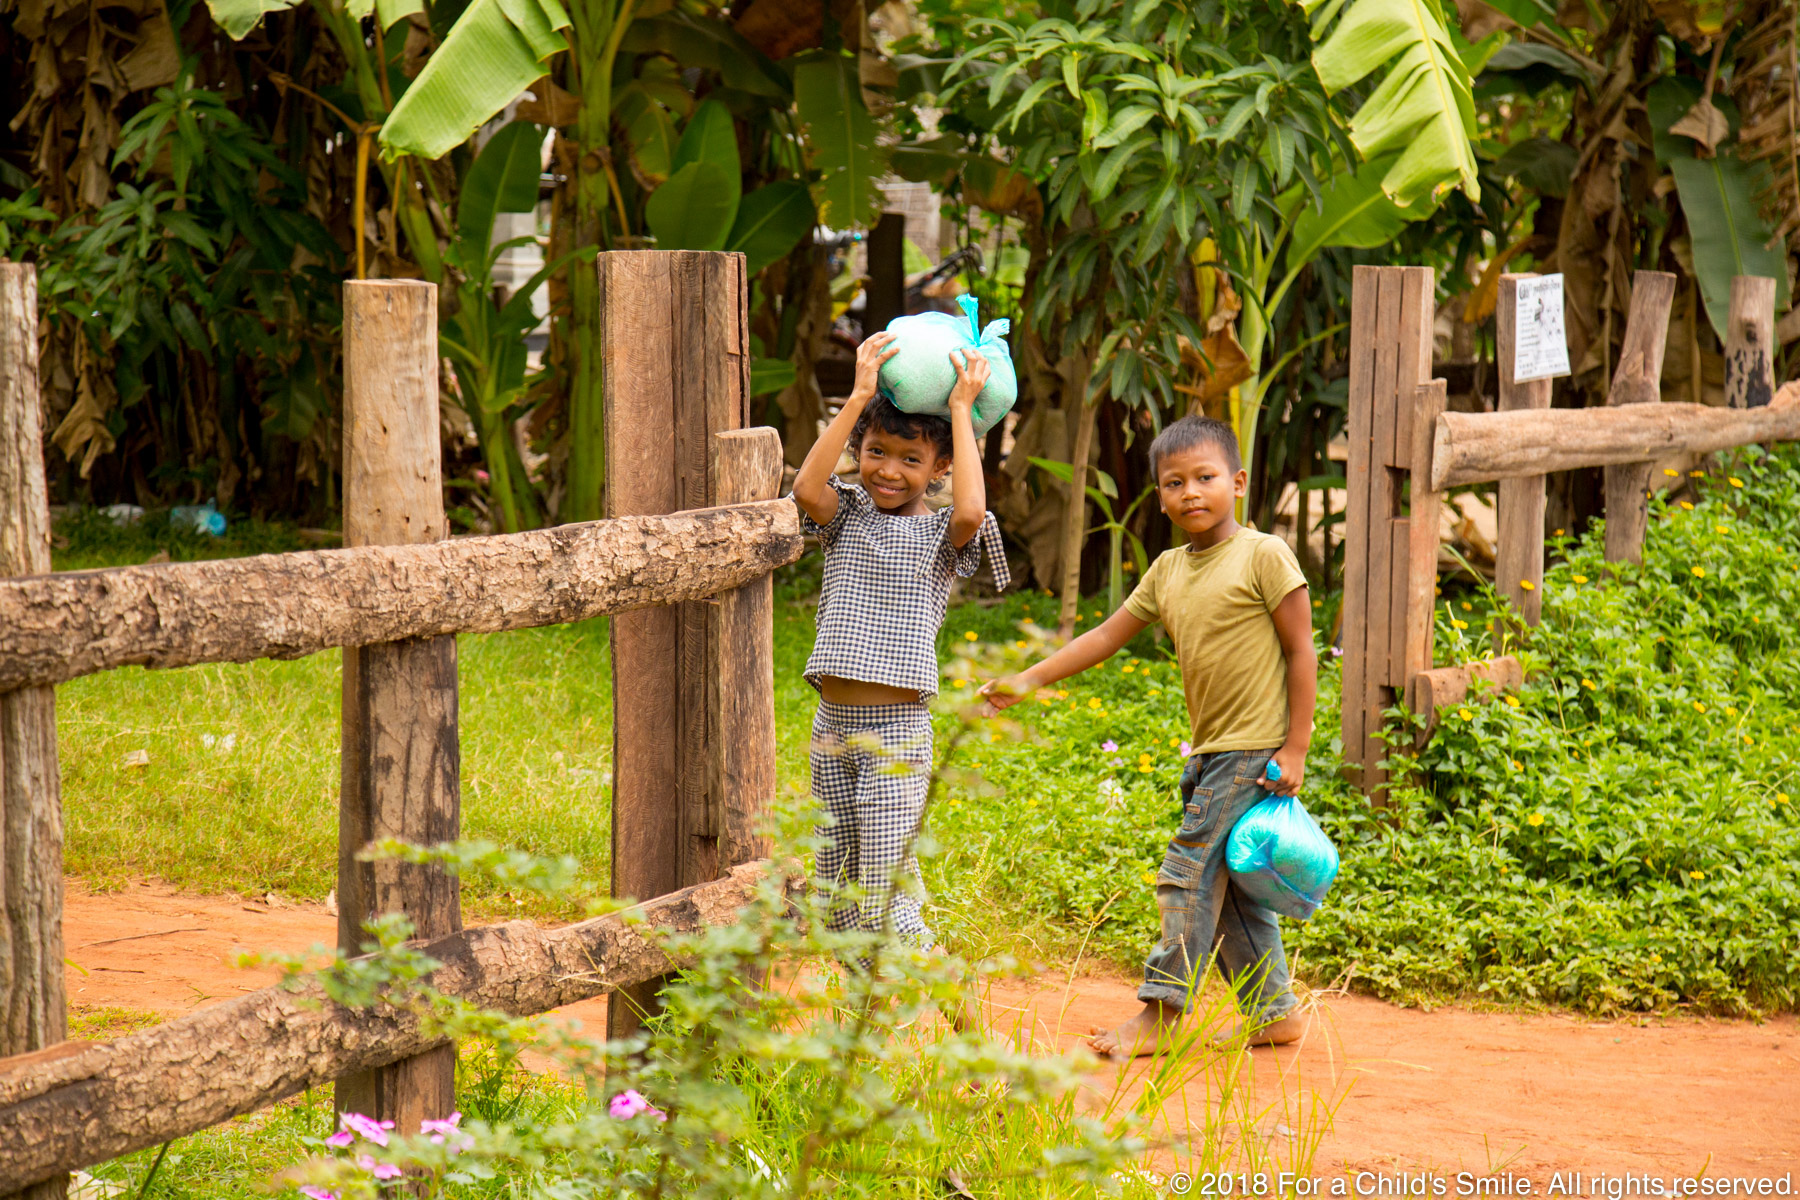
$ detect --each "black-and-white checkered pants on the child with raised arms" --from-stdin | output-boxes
[812,700,934,948]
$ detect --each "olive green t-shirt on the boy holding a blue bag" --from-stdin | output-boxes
[1125,529,1307,754]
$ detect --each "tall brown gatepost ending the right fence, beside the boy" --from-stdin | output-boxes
[1341,266,1440,795]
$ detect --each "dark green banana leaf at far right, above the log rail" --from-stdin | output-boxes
[1669,149,1787,342]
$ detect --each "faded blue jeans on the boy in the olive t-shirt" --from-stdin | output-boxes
[1138,750,1296,1024]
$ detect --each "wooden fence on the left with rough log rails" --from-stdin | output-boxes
[0,252,801,1200]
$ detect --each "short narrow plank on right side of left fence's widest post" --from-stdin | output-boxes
[707,428,781,869]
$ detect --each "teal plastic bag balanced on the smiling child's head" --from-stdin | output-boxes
[878,295,1019,437]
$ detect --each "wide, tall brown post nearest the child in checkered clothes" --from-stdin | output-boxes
[596,250,774,1038]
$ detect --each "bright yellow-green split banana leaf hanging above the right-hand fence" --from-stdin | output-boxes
[1305,0,1481,207]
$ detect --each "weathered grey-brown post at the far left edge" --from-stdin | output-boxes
[0,263,68,1200]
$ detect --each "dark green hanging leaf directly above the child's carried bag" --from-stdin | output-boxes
[794,56,889,228]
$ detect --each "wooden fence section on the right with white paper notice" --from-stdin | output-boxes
[1341,266,1800,795]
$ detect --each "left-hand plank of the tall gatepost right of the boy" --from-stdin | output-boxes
[1337,266,1381,784]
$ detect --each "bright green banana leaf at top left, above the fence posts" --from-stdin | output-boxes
[378,0,569,158]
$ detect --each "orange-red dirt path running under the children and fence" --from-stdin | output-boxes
[65,882,1800,1195]
